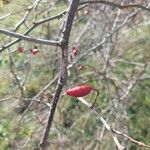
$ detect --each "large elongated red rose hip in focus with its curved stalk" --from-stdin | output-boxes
[66,85,99,107]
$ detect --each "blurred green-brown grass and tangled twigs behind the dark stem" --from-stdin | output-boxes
[0,0,150,150]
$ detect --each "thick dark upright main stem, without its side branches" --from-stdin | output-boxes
[39,0,79,149]
